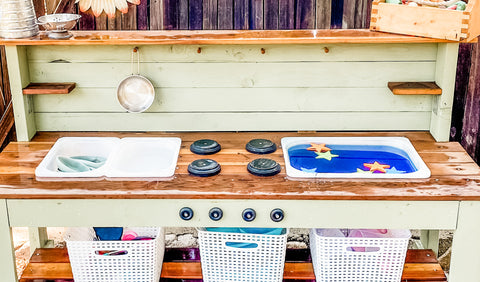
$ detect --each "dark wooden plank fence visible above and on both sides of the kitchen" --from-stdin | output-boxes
[0,0,480,163]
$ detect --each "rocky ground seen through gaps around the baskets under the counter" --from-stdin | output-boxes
[13,227,453,276]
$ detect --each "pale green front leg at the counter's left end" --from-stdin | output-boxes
[0,199,18,282]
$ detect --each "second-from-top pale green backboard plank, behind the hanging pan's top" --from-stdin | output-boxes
[30,62,435,87]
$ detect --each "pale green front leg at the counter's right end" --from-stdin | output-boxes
[448,202,480,282]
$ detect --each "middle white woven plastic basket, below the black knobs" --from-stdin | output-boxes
[198,228,288,282]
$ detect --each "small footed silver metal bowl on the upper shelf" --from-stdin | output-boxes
[38,14,81,39]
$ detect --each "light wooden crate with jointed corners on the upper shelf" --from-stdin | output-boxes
[370,0,480,41]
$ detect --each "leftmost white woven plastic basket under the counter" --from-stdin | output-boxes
[65,227,165,282]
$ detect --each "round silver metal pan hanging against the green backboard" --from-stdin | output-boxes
[117,75,155,113]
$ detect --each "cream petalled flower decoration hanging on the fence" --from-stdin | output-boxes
[75,0,140,18]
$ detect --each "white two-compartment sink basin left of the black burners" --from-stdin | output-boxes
[35,137,181,180]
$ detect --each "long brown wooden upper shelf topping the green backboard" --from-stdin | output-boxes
[0,29,460,45]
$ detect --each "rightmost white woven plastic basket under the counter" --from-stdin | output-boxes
[310,229,411,282]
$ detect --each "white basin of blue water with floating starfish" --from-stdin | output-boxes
[282,137,430,178]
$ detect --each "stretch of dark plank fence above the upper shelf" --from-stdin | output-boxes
[34,0,372,30]
